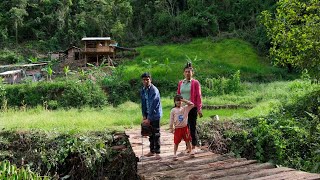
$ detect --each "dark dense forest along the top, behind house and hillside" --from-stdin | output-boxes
[0,0,274,51]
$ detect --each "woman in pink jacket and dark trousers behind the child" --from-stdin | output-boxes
[177,62,202,151]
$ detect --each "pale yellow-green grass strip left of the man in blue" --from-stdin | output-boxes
[0,102,141,131]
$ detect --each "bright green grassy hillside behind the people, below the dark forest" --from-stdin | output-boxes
[123,39,286,81]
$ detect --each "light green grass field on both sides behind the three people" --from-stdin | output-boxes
[0,80,319,131]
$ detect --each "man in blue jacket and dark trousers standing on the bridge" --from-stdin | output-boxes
[140,73,162,159]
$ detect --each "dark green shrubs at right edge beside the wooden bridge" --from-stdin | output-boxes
[222,90,320,173]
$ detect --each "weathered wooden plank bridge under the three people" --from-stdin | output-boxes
[126,129,320,180]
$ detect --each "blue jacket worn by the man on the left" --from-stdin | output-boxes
[140,84,162,121]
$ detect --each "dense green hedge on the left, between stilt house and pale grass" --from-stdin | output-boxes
[0,81,106,109]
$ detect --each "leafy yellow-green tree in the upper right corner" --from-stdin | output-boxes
[262,0,320,80]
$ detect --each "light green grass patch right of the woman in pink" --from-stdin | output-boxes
[203,80,319,119]
